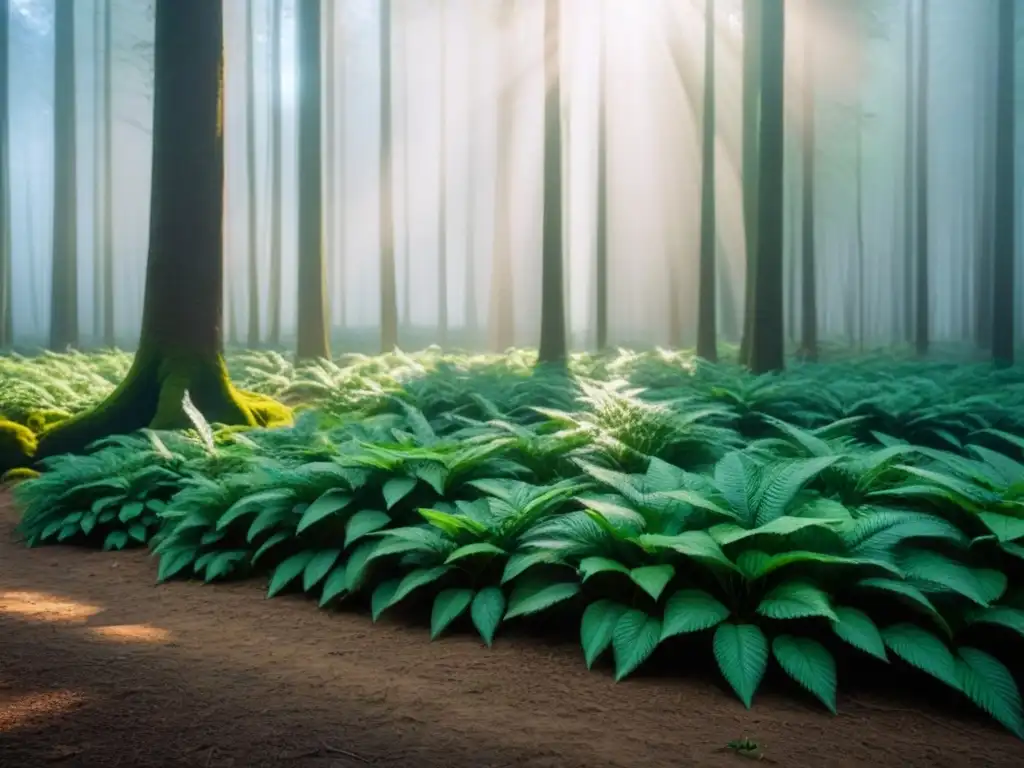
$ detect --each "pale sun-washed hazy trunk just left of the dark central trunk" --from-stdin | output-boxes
[488,0,516,352]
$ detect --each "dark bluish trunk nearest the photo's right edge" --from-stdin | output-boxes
[992,0,1017,366]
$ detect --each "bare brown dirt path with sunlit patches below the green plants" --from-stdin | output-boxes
[0,493,1024,768]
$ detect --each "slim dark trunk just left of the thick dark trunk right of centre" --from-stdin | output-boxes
[697,0,718,361]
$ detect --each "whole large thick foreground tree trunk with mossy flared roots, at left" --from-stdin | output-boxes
[37,0,283,458]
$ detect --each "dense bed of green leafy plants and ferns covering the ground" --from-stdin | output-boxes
[6,349,1024,737]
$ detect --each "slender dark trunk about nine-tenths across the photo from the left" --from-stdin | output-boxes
[913,0,931,356]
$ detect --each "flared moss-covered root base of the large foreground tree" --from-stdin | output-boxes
[35,345,292,461]
